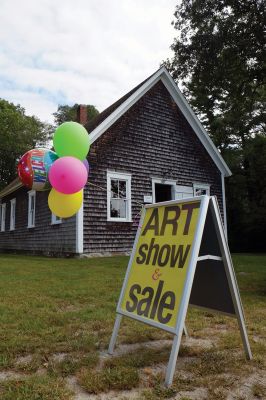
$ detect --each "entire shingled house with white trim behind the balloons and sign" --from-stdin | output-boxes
[0,67,231,255]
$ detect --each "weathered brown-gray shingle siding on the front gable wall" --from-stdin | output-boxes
[84,81,222,253]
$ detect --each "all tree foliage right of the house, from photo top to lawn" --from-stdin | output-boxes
[164,0,266,250]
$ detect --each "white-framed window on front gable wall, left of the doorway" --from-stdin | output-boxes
[107,172,131,222]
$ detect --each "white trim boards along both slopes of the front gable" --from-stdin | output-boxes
[90,67,232,176]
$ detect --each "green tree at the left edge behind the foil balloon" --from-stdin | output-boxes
[0,99,52,188]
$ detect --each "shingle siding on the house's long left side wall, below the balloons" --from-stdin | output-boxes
[0,187,76,254]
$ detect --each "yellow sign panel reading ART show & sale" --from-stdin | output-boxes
[118,200,201,330]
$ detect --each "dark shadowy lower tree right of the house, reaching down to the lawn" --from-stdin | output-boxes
[226,135,266,251]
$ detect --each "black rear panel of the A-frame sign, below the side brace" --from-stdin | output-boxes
[189,260,235,315]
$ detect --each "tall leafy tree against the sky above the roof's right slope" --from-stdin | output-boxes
[165,0,266,151]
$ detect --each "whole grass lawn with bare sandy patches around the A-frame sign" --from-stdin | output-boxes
[0,254,266,400]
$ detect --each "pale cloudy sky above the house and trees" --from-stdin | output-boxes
[0,0,177,123]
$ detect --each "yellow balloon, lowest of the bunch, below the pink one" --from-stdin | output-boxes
[48,189,83,218]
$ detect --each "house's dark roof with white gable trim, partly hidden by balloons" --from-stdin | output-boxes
[0,67,232,198]
